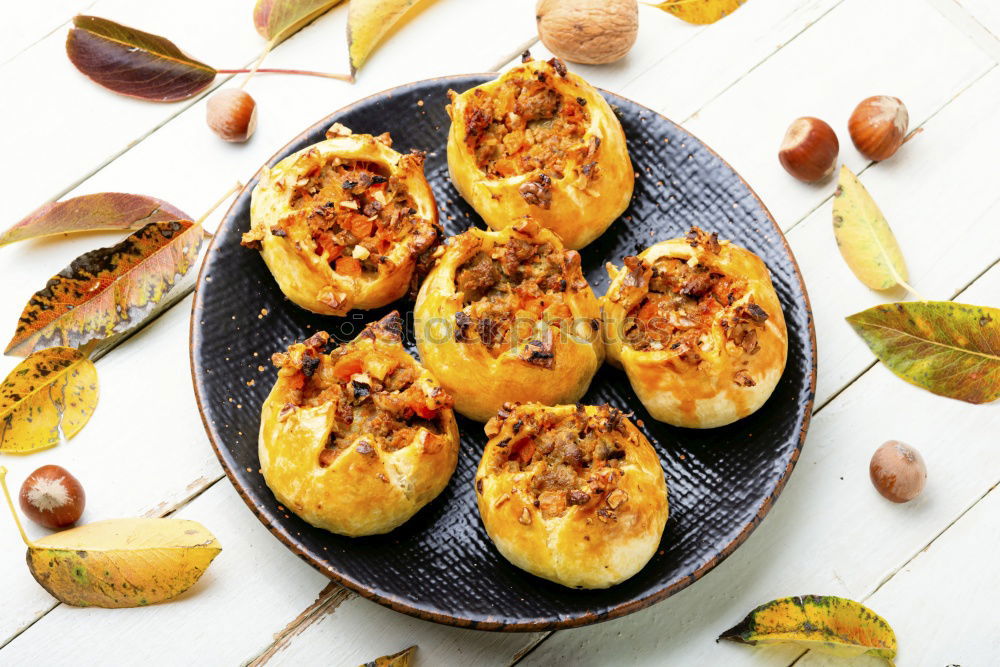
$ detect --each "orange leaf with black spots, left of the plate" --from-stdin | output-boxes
[6,220,204,355]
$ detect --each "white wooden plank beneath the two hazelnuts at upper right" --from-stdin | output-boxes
[686,0,995,235]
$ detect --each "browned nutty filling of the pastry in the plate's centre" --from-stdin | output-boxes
[454,232,587,368]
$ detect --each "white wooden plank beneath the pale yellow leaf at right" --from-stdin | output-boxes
[788,68,1000,405]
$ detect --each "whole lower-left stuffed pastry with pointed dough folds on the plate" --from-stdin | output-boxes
[259,312,458,537]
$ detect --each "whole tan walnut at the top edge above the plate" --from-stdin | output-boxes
[535,0,639,65]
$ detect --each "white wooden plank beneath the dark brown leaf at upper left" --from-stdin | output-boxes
[0,0,268,227]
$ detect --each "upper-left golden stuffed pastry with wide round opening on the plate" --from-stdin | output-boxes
[243,124,441,315]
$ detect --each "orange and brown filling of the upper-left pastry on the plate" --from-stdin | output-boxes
[243,151,441,276]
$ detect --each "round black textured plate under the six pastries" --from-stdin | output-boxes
[191,75,816,630]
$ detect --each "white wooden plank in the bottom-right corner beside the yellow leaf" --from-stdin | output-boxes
[795,482,1000,667]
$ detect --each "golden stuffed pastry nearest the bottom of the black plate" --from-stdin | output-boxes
[475,404,668,588]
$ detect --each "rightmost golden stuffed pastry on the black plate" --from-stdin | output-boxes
[601,228,788,428]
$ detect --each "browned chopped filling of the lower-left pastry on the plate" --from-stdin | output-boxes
[272,331,452,467]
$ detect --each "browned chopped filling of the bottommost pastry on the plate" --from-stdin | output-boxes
[479,404,632,522]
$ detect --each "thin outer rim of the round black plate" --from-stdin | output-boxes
[188,72,818,632]
